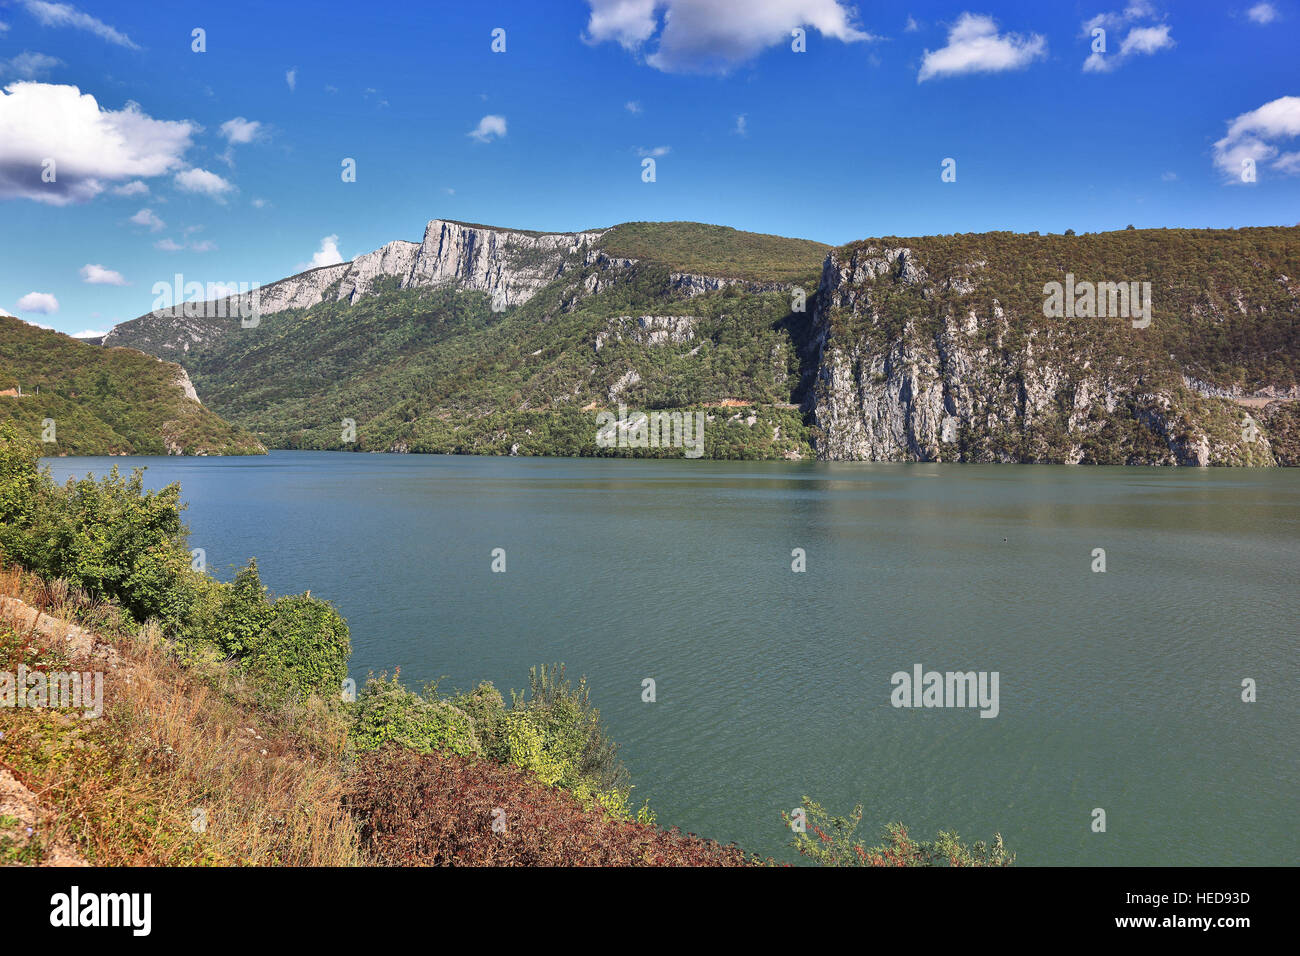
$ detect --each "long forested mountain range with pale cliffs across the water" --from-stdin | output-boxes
[22,220,1300,466]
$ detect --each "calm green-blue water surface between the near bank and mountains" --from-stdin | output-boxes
[49,451,1300,865]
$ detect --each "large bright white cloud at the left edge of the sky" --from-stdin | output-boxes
[0,83,198,206]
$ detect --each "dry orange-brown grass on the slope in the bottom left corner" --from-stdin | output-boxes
[0,570,360,866]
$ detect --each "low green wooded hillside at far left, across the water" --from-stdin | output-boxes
[0,316,265,455]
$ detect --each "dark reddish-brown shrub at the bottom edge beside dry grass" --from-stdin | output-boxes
[347,747,753,866]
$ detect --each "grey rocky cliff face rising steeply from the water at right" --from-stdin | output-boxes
[806,246,1273,466]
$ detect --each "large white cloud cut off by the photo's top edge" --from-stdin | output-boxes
[584,0,875,73]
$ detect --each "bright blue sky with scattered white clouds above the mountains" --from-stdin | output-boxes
[0,0,1300,333]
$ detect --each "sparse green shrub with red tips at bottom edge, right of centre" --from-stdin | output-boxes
[781,797,1015,866]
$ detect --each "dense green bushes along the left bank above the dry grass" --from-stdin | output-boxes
[0,424,351,700]
